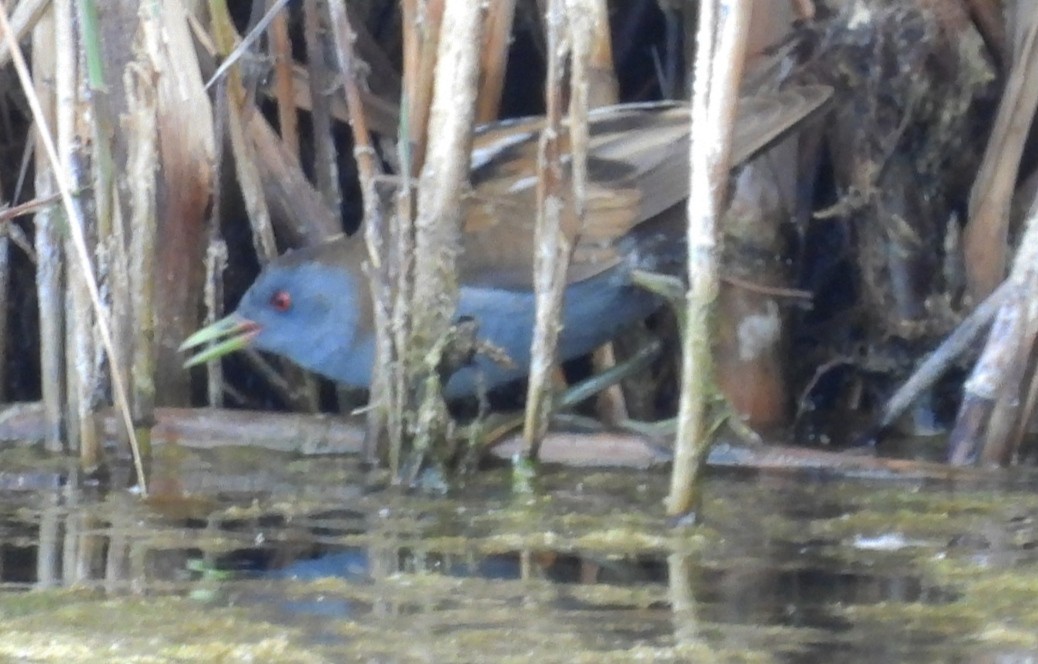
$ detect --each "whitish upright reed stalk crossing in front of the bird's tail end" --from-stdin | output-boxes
[666,0,750,516]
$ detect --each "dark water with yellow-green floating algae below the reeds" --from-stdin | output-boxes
[0,439,1038,662]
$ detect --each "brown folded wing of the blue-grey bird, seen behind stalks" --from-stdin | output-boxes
[459,87,830,289]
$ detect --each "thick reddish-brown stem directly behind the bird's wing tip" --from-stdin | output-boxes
[713,0,809,432]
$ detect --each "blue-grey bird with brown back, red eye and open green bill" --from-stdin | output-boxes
[181,86,831,399]
